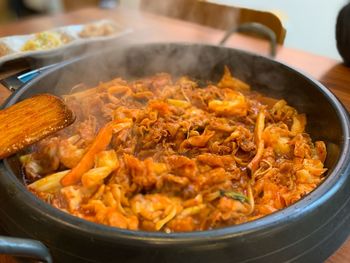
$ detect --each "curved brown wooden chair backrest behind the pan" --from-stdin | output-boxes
[141,0,286,44]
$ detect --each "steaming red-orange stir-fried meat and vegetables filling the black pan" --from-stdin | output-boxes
[21,68,326,233]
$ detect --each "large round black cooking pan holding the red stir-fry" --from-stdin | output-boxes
[0,43,350,263]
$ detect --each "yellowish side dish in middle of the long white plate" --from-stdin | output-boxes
[22,31,72,51]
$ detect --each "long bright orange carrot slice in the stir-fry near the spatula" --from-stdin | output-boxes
[61,122,113,186]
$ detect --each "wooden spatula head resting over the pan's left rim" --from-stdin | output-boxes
[0,94,75,159]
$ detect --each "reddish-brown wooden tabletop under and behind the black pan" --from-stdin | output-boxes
[0,8,350,263]
